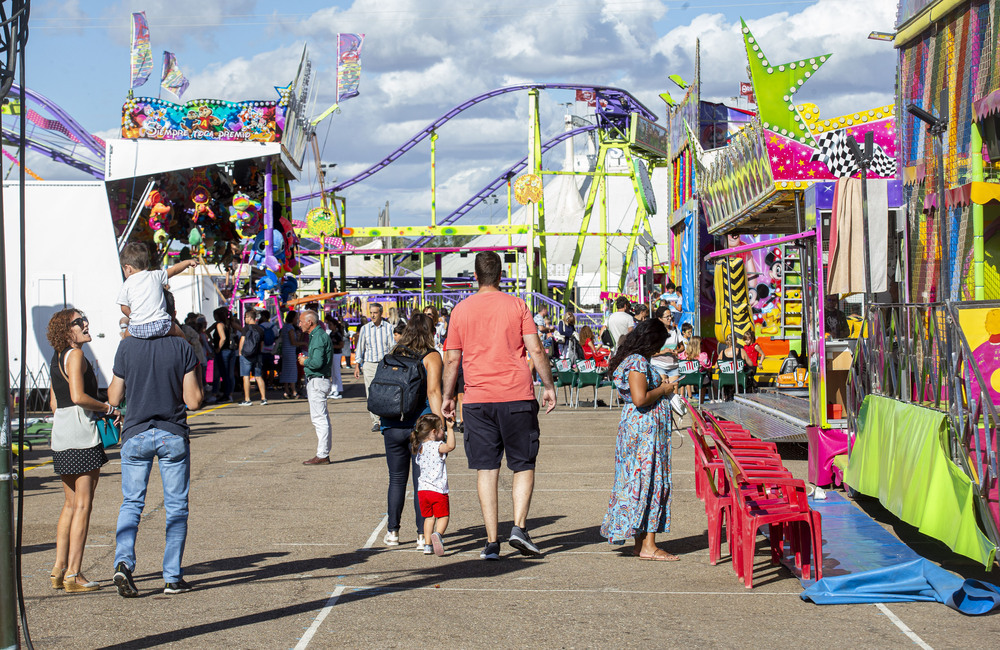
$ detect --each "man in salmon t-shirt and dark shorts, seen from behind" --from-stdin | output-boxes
[441,251,556,560]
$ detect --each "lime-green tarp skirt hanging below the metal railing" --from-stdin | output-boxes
[845,395,997,569]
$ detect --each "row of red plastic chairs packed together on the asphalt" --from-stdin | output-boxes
[688,398,823,589]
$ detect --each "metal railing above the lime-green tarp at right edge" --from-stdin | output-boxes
[847,301,1000,543]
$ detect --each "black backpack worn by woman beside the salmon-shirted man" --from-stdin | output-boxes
[368,348,433,420]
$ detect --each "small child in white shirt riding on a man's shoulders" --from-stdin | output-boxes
[118,242,198,339]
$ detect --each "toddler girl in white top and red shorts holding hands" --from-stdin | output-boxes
[410,413,455,556]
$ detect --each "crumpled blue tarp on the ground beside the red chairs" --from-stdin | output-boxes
[800,492,1000,615]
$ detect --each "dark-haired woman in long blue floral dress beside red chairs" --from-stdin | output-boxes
[601,318,678,561]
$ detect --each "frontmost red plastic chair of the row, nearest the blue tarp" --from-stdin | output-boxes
[720,445,823,589]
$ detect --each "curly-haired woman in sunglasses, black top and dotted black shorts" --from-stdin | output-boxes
[46,309,121,593]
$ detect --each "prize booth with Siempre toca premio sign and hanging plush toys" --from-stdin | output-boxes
[105,54,310,313]
